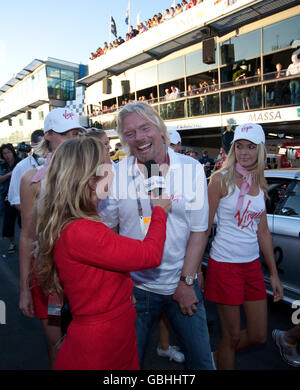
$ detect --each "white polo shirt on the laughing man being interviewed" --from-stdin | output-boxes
[100,148,208,295]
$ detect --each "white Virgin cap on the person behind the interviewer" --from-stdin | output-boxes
[44,107,86,133]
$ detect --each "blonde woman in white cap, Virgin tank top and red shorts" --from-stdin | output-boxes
[205,123,283,369]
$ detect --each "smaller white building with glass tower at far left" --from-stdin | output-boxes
[0,57,87,144]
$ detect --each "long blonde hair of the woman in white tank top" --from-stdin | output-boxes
[211,143,268,198]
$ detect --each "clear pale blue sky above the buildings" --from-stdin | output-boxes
[0,0,175,87]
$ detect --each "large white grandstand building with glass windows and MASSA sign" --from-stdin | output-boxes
[78,0,300,162]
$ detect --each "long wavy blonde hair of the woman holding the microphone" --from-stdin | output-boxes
[35,137,105,294]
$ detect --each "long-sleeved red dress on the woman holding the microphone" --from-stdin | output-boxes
[54,207,167,370]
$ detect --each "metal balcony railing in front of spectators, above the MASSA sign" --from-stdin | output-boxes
[92,72,300,129]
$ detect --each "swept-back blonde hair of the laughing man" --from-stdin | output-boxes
[117,101,170,155]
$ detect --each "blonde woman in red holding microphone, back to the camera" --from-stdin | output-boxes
[36,136,171,370]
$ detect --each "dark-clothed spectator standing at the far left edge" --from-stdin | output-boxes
[0,144,20,253]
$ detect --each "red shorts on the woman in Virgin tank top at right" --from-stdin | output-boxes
[204,258,267,305]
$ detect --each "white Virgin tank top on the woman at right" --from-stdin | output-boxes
[210,186,265,263]
